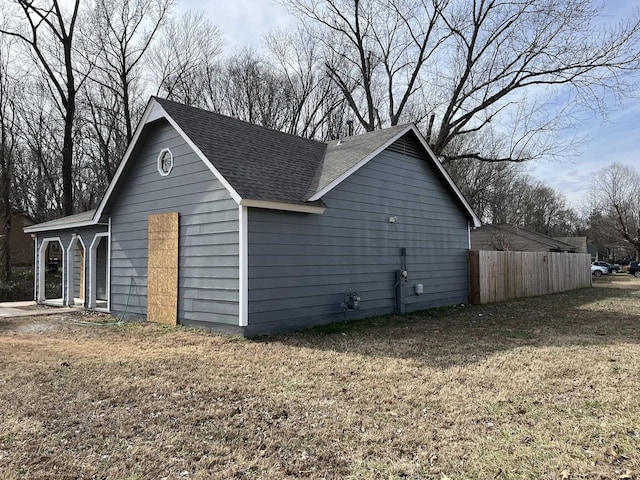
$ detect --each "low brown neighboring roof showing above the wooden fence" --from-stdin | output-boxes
[471,223,577,253]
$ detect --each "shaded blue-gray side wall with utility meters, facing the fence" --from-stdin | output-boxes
[245,131,469,334]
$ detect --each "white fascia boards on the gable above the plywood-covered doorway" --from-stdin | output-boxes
[94,98,241,218]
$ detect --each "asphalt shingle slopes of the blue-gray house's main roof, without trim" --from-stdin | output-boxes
[155,97,418,205]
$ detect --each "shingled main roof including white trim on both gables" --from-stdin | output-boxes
[91,96,479,225]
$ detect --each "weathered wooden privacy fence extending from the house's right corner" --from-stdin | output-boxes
[469,250,591,304]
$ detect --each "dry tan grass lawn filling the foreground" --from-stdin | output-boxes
[0,274,640,480]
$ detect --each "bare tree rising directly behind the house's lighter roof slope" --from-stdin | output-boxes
[282,0,449,131]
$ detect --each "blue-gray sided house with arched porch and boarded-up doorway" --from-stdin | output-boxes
[26,98,480,335]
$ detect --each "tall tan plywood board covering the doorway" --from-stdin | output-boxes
[147,212,178,325]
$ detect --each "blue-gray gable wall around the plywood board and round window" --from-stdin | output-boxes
[107,122,239,325]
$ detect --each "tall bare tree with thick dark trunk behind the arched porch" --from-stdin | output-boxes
[0,0,89,215]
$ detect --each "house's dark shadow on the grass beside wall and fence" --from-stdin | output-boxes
[256,277,640,368]
